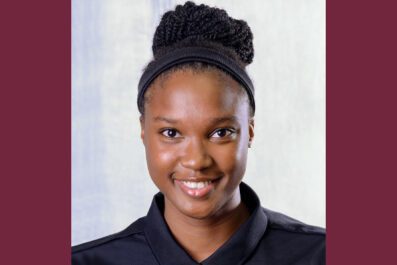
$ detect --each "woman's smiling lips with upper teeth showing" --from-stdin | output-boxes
[174,175,219,199]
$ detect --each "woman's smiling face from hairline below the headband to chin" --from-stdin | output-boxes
[141,70,253,219]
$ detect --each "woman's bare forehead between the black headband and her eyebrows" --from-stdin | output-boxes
[145,69,248,118]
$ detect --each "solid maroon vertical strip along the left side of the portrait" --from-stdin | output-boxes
[0,0,71,265]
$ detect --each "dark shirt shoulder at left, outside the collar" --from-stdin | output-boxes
[72,217,150,265]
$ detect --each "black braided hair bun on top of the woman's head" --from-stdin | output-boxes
[152,1,254,65]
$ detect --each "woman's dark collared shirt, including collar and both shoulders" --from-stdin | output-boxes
[72,183,325,265]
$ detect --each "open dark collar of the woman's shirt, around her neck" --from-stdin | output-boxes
[145,182,268,265]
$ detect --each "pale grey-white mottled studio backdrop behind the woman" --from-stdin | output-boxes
[72,0,325,245]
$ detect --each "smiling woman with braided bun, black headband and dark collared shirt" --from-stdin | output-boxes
[72,2,325,265]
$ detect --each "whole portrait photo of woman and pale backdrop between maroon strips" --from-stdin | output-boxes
[71,0,326,265]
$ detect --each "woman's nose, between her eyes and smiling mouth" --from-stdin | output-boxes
[181,139,213,171]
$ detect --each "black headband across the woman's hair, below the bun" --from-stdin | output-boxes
[138,47,255,113]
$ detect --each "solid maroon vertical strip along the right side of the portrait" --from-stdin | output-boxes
[326,0,397,265]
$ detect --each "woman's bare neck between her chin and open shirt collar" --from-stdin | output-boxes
[164,190,249,262]
